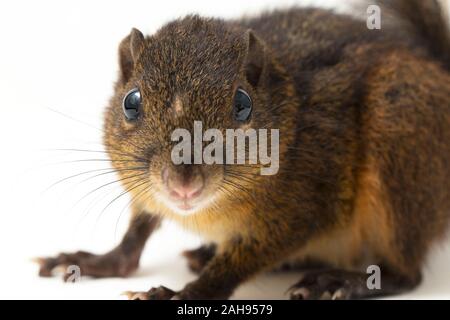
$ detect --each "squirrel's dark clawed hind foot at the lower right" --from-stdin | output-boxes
[289,269,421,300]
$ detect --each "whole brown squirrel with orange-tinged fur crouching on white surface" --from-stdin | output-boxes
[40,0,450,299]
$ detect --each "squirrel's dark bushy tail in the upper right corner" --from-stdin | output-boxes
[378,0,450,70]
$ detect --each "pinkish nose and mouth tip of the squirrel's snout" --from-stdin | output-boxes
[162,165,205,200]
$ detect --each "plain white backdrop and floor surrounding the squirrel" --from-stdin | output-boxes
[0,0,450,299]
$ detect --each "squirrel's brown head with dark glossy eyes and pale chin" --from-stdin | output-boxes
[104,16,297,219]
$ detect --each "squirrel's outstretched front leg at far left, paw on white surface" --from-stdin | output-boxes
[35,213,159,281]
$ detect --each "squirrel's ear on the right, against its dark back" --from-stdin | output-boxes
[244,29,266,87]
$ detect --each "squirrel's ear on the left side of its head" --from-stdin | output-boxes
[119,28,144,83]
